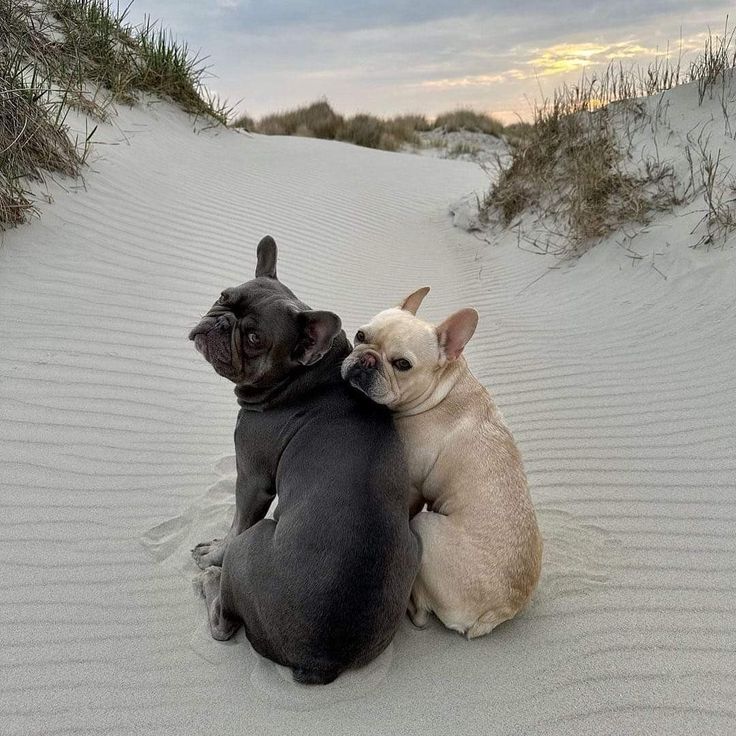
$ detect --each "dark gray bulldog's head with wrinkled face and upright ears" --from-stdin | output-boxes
[189,236,341,388]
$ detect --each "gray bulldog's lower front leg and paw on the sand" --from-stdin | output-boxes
[192,472,276,570]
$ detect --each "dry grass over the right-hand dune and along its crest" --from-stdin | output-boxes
[480,21,736,257]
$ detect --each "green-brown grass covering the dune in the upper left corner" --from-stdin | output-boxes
[0,0,228,228]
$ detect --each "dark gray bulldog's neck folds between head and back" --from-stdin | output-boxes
[235,332,352,411]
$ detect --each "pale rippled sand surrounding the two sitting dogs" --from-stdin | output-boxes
[0,87,736,736]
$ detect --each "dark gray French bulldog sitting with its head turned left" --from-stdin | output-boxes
[189,236,420,684]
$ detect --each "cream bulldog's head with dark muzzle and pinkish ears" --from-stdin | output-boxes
[342,287,478,411]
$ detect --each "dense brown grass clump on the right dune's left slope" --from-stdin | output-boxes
[482,89,676,256]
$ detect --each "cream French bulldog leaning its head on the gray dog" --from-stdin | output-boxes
[342,287,542,638]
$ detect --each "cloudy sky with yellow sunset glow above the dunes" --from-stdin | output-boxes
[131,0,733,122]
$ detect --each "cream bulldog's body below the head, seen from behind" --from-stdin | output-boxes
[396,358,542,638]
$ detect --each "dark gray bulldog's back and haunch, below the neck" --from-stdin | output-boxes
[222,381,420,682]
